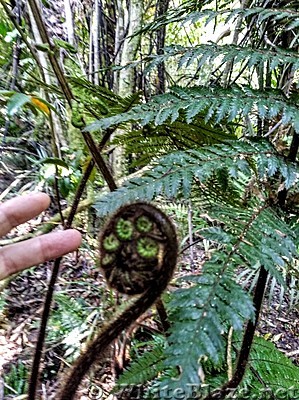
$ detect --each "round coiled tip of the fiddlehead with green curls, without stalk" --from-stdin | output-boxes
[100,202,178,295]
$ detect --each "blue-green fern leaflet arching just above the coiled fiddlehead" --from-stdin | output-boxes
[95,141,299,215]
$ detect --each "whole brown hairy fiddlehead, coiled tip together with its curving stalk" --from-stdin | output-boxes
[57,202,178,400]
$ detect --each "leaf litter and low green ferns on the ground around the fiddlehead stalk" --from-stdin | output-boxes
[0,195,299,400]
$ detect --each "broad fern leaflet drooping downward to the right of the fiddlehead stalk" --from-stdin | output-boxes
[154,200,297,396]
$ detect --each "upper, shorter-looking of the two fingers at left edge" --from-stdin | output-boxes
[0,193,50,236]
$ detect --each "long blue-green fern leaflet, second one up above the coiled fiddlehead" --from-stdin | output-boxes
[86,86,299,132]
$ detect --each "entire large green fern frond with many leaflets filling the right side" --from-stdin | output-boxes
[87,0,299,399]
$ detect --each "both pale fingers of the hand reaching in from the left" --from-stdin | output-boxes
[0,193,81,280]
